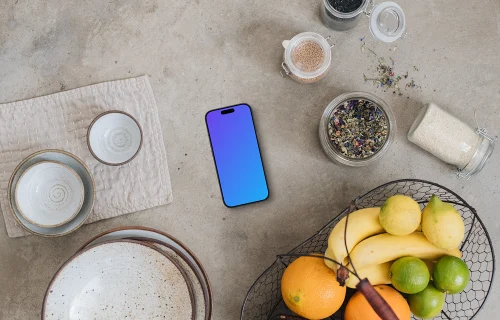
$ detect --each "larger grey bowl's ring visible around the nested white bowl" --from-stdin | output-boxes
[7,150,95,237]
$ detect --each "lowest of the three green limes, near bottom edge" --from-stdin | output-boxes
[408,281,445,319]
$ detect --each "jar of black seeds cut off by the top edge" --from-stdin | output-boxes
[320,0,371,31]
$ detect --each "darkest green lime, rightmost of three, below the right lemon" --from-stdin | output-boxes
[432,256,470,294]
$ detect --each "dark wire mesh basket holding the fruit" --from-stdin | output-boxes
[240,179,495,320]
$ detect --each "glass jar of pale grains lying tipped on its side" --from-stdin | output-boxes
[408,103,496,179]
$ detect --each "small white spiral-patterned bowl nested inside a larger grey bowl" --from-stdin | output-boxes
[15,161,85,228]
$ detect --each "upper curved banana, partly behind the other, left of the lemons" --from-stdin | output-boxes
[325,208,385,271]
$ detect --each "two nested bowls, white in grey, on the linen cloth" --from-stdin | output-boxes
[8,150,95,237]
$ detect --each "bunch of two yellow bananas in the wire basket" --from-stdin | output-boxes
[324,208,462,288]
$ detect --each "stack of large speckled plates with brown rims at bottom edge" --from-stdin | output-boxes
[42,227,212,320]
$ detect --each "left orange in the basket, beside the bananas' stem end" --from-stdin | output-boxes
[281,255,346,319]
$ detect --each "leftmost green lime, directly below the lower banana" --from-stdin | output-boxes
[389,257,431,294]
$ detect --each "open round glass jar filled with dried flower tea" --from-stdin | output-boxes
[319,92,396,167]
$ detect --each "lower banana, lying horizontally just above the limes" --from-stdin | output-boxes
[350,232,462,269]
